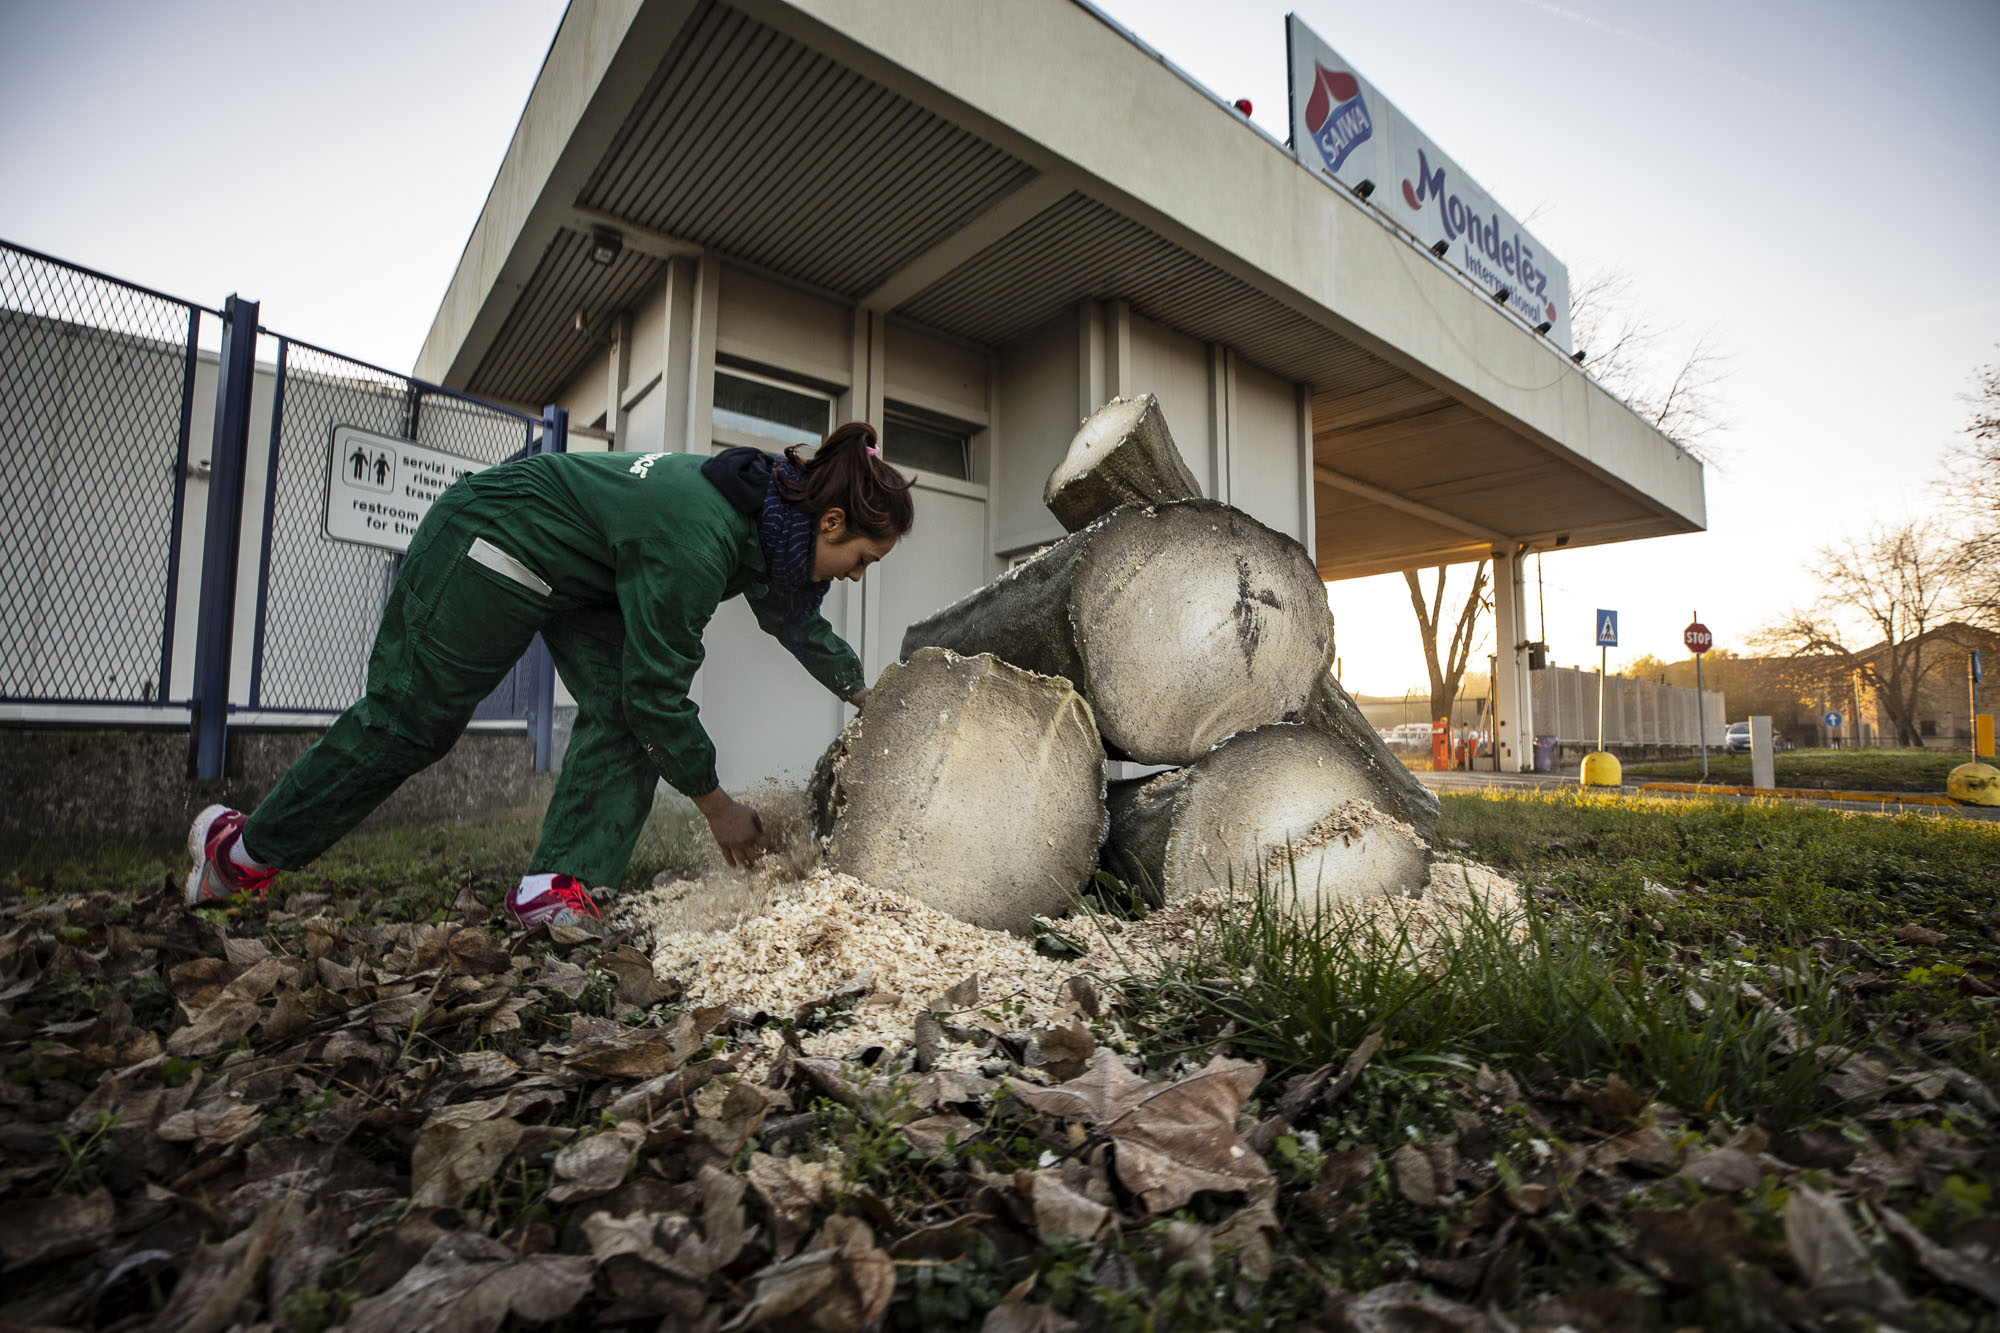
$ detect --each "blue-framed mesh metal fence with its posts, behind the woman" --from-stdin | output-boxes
[0,242,568,777]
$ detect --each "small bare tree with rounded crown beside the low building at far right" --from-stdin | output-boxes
[1756,520,1958,749]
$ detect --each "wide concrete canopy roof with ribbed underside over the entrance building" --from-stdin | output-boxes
[416,0,1706,578]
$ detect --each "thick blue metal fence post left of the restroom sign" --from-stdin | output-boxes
[192,296,258,779]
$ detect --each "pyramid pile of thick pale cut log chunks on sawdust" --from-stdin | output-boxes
[814,394,1438,933]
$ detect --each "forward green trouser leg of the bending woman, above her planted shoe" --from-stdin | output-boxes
[528,610,660,887]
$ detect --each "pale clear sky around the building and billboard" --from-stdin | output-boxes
[0,0,2000,695]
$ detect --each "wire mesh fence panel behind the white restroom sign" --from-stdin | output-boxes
[250,338,540,719]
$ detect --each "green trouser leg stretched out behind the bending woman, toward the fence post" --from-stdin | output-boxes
[244,492,548,871]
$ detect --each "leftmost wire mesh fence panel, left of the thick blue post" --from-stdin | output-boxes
[0,244,212,705]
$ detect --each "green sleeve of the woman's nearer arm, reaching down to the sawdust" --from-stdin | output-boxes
[616,540,726,797]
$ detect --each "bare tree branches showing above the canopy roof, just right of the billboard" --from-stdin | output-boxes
[1570,268,1730,466]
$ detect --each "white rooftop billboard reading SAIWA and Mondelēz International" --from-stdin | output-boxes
[1284,14,1570,350]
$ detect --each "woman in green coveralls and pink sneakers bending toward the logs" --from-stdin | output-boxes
[186,422,914,927]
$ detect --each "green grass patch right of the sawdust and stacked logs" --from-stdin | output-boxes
[1138,795,2000,1129]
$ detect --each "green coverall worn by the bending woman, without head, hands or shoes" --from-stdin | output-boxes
[244,454,866,885]
